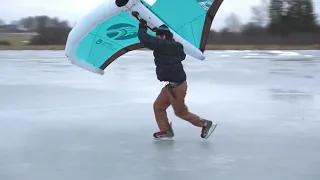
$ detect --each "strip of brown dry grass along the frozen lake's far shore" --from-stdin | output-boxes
[0,44,320,51]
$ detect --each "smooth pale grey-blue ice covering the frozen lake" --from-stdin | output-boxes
[0,51,320,180]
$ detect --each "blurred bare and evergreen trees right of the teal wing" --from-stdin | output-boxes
[208,0,320,45]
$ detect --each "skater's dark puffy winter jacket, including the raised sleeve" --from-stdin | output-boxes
[138,27,187,83]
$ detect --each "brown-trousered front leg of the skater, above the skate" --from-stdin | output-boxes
[153,84,170,132]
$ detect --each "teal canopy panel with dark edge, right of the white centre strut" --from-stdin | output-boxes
[142,0,223,52]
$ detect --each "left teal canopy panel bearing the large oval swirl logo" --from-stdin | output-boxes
[76,12,153,70]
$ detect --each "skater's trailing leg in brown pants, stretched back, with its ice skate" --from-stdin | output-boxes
[169,81,217,138]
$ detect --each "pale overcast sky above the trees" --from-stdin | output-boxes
[0,0,320,29]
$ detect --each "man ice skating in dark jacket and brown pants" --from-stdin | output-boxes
[138,19,217,139]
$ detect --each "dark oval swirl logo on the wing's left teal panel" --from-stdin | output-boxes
[107,23,138,40]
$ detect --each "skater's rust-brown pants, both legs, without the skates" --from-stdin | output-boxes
[153,81,204,132]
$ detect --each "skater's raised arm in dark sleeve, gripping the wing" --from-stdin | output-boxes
[138,20,166,50]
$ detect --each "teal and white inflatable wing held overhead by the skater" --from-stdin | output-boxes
[65,0,223,74]
